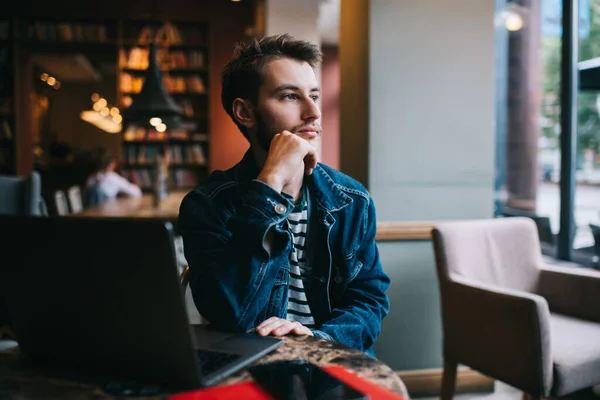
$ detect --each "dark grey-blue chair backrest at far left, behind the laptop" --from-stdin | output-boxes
[0,171,42,215]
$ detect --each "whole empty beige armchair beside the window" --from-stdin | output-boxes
[433,217,600,399]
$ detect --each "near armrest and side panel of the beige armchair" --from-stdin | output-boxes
[442,277,552,396]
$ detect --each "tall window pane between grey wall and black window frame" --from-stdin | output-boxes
[495,0,561,255]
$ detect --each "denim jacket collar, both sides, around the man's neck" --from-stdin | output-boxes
[233,149,352,212]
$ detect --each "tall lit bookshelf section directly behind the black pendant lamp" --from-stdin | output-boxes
[117,20,209,190]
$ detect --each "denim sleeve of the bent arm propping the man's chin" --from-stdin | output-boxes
[177,180,293,331]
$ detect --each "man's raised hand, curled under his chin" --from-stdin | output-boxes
[257,131,317,192]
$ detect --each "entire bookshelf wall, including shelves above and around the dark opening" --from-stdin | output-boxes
[0,16,210,181]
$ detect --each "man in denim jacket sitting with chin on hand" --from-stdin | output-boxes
[178,35,389,354]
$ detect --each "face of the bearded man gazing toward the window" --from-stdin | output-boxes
[250,58,322,153]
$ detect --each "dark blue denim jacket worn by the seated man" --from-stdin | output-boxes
[178,151,390,355]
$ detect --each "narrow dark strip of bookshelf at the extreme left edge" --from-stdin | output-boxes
[0,18,16,175]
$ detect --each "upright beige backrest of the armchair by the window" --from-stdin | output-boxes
[433,217,542,292]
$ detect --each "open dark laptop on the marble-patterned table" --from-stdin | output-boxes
[0,216,282,391]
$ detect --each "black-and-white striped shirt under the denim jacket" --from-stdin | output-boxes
[286,193,315,328]
